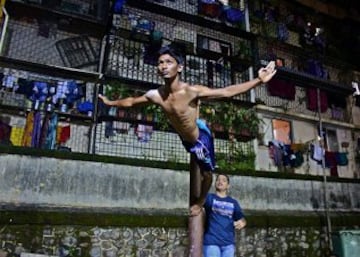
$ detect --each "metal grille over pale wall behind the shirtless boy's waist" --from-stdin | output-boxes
[95,118,254,163]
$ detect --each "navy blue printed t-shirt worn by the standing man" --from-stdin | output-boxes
[204,194,244,246]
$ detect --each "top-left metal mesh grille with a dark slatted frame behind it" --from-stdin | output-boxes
[3,19,100,71]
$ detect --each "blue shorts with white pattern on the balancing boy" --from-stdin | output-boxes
[182,119,215,171]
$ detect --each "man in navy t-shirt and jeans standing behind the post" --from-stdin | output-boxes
[203,174,246,257]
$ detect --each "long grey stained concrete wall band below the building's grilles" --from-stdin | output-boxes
[0,154,360,214]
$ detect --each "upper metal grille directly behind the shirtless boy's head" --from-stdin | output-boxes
[105,4,250,99]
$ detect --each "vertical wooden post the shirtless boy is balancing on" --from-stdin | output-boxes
[188,155,204,257]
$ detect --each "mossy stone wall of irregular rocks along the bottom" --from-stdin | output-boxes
[0,225,332,257]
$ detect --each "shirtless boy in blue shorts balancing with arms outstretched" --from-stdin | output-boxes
[99,46,276,216]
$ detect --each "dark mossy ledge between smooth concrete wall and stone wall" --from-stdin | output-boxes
[0,209,360,228]
